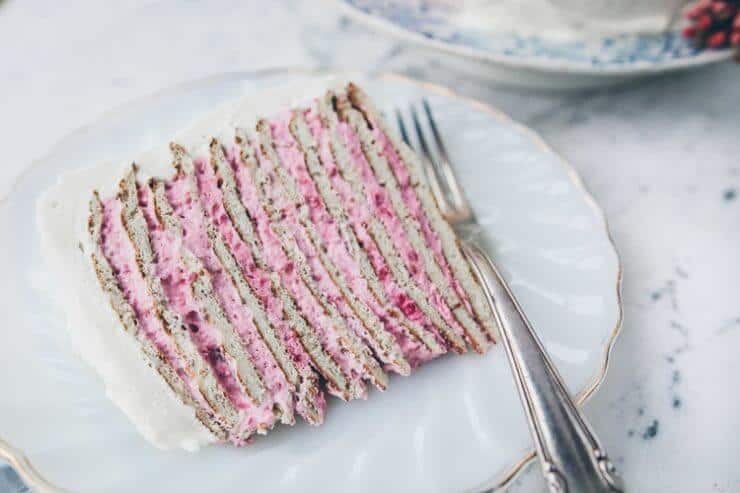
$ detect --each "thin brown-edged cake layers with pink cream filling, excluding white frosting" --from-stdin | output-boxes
[89,84,494,445]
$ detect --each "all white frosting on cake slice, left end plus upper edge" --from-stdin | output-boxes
[36,79,340,451]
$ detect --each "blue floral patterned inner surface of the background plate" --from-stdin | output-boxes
[342,0,716,70]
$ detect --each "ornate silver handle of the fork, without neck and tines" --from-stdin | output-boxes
[463,241,624,493]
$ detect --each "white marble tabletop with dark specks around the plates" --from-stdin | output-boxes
[0,0,740,493]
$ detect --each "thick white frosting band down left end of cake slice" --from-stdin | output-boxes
[37,163,217,450]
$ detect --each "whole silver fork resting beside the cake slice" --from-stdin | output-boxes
[394,99,624,493]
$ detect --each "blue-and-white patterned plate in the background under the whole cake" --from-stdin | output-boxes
[336,0,732,89]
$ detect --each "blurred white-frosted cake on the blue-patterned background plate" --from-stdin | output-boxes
[457,0,687,41]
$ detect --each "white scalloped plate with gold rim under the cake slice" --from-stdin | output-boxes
[0,71,621,493]
